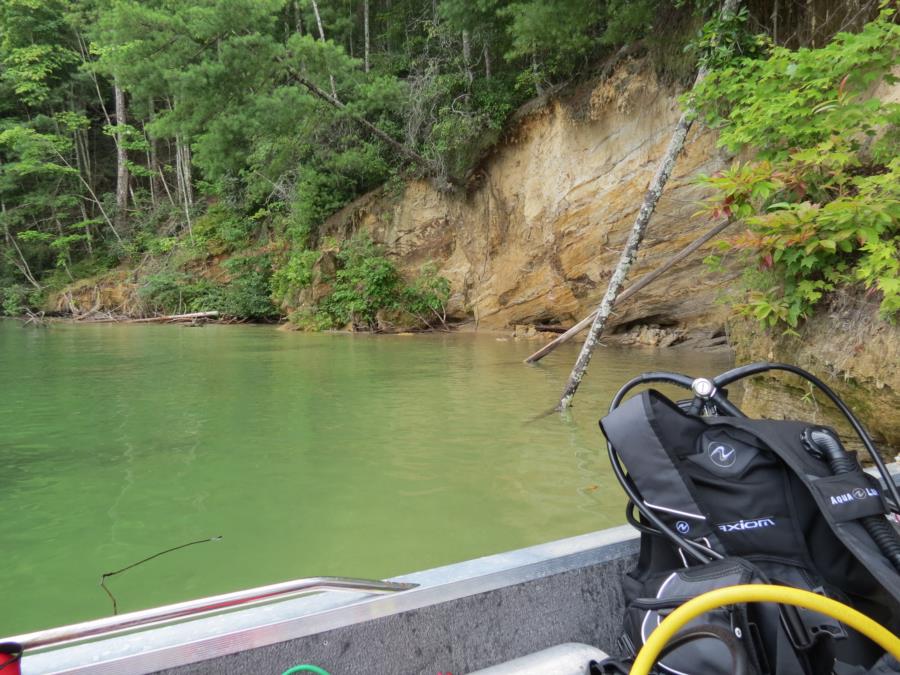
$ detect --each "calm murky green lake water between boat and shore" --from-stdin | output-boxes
[0,321,730,636]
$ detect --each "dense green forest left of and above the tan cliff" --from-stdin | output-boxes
[0,0,724,326]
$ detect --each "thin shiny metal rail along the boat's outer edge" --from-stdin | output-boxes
[0,577,418,651]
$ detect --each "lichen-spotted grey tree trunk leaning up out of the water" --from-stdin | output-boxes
[556,0,740,411]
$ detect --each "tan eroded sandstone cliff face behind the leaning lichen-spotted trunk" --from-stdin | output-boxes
[326,63,740,335]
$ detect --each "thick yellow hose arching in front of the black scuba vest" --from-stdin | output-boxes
[630,584,900,675]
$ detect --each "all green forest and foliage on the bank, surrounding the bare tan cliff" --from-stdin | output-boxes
[0,0,900,328]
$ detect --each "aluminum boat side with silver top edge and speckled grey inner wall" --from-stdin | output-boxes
[12,526,638,675]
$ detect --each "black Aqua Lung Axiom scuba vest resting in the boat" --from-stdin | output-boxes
[597,364,900,675]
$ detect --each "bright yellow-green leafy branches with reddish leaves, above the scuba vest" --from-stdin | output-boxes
[696,12,900,329]
